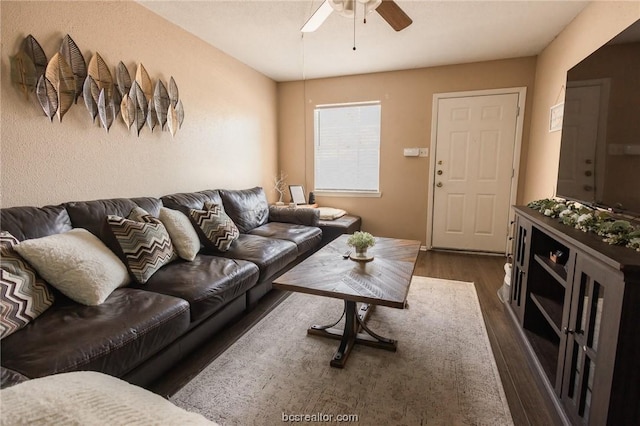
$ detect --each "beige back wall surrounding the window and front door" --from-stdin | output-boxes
[278,57,536,244]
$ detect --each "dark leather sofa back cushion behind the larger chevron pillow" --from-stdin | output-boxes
[64,197,162,258]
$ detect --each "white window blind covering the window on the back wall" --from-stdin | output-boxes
[314,102,381,192]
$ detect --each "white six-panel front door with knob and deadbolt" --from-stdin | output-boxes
[431,93,519,253]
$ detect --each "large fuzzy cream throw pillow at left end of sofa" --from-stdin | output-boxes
[15,228,130,305]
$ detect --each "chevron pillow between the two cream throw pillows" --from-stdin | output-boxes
[107,207,177,284]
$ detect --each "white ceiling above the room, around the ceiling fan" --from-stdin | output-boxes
[138,0,589,81]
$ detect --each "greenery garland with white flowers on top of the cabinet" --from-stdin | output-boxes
[527,198,640,251]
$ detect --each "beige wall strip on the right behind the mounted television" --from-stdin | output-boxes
[521,1,640,202]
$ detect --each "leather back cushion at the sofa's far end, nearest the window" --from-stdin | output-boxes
[218,187,269,234]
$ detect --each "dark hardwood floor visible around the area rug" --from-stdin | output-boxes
[150,251,562,426]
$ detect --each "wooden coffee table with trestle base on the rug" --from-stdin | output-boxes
[273,235,420,368]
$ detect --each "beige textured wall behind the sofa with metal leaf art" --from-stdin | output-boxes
[0,0,277,207]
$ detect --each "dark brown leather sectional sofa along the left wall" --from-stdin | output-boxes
[0,188,330,386]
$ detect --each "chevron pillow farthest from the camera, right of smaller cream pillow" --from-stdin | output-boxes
[189,202,240,251]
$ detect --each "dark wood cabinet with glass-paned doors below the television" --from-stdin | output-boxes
[509,207,640,425]
